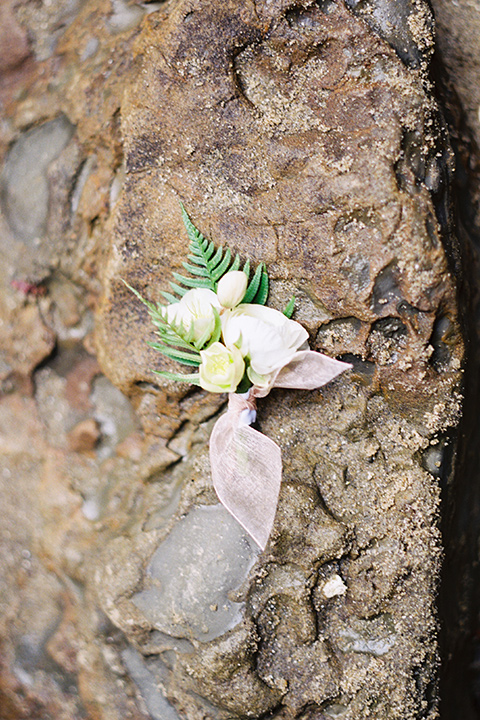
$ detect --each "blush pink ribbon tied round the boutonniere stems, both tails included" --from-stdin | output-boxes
[210,350,352,550]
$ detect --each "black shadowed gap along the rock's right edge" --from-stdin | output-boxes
[432,51,480,720]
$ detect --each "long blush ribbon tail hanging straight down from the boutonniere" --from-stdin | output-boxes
[210,413,282,550]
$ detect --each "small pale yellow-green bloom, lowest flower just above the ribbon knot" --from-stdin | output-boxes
[198,342,245,392]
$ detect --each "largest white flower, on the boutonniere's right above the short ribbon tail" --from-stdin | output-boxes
[222,304,308,387]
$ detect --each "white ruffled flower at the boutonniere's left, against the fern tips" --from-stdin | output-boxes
[167,288,220,340]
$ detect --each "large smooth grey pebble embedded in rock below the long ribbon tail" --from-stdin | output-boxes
[132,505,260,642]
